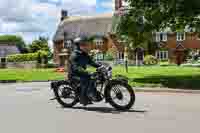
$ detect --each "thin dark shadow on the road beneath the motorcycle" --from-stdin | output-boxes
[69,107,147,114]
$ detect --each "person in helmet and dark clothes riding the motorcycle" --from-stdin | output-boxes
[69,37,101,105]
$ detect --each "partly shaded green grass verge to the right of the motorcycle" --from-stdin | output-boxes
[111,66,200,89]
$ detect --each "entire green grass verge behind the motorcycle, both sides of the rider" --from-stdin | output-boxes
[0,66,200,89]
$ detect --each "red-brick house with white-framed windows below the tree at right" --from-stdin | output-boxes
[154,32,200,63]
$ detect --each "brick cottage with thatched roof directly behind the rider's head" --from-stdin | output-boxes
[53,13,126,66]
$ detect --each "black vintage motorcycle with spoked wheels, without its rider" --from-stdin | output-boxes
[51,63,135,110]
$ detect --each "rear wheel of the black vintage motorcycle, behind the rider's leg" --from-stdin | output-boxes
[53,82,79,108]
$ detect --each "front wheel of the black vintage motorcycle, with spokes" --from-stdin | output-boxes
[105,81,135,110]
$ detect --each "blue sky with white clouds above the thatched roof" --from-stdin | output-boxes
[0,0,114,47]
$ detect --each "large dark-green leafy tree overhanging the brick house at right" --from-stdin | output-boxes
[113,0,200,53]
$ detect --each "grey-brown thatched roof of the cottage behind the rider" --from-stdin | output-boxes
[53,13,113,42]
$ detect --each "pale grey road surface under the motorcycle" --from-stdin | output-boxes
[0,82,200,133]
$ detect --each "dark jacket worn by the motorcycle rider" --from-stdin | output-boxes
[69,45,100,77]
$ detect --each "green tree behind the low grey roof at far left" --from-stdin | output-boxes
[0,35,28,53]
